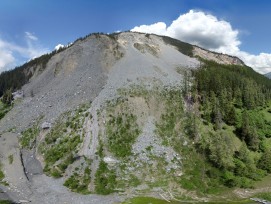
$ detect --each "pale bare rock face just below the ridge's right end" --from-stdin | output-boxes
[193,46,244,65]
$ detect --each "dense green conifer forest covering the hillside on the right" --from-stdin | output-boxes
[183,59,271,192]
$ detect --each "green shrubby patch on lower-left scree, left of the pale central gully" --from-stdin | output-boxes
[39,105,88,178]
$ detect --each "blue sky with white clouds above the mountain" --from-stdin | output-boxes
[0,0,271,73]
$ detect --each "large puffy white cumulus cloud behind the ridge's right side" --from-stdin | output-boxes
[131,10,271,73]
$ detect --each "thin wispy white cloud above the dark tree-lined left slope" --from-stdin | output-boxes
[0,32,49,73]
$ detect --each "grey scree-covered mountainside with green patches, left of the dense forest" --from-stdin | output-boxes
[0,32,270,203]
